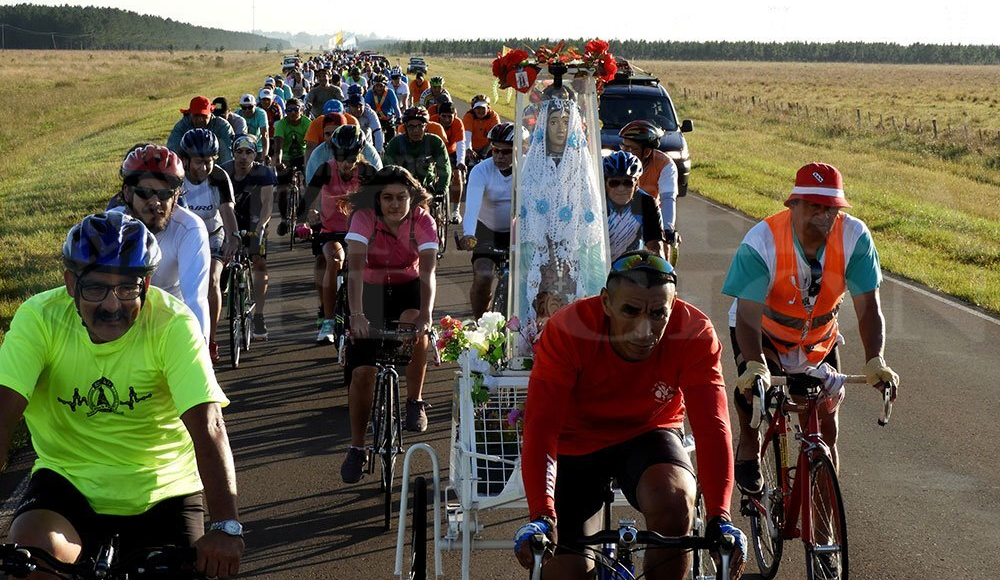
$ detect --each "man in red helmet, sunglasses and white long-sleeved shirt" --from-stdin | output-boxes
[115,145,211,340]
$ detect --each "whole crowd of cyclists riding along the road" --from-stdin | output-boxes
[0,46,898,578]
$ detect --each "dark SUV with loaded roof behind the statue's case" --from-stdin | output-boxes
[600,68,694,197]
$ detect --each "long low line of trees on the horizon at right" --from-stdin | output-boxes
[379,38,1000,64]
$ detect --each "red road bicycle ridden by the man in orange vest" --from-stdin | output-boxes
[740,375,895,580]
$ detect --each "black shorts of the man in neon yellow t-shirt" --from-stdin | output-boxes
[14,469,205,556]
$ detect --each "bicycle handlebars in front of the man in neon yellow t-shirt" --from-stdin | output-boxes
[0,536,205,580]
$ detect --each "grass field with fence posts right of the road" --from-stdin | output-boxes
[438,59,1000,313]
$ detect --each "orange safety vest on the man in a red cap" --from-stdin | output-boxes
[761,209,847,365]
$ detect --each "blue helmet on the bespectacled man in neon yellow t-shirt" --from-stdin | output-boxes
[63,211,160,278]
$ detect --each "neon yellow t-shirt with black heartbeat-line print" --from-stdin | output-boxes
[0,287,229,515]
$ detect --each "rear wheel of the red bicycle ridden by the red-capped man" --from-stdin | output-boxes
[748,437,785,580]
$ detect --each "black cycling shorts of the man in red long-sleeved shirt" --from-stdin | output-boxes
[555,429,695,554]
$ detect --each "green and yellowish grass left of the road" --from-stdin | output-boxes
[0,51,280,338]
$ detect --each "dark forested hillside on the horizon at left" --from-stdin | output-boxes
[0,4,290,51]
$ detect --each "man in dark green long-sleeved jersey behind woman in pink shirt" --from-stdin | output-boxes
[383,107,451,195]
